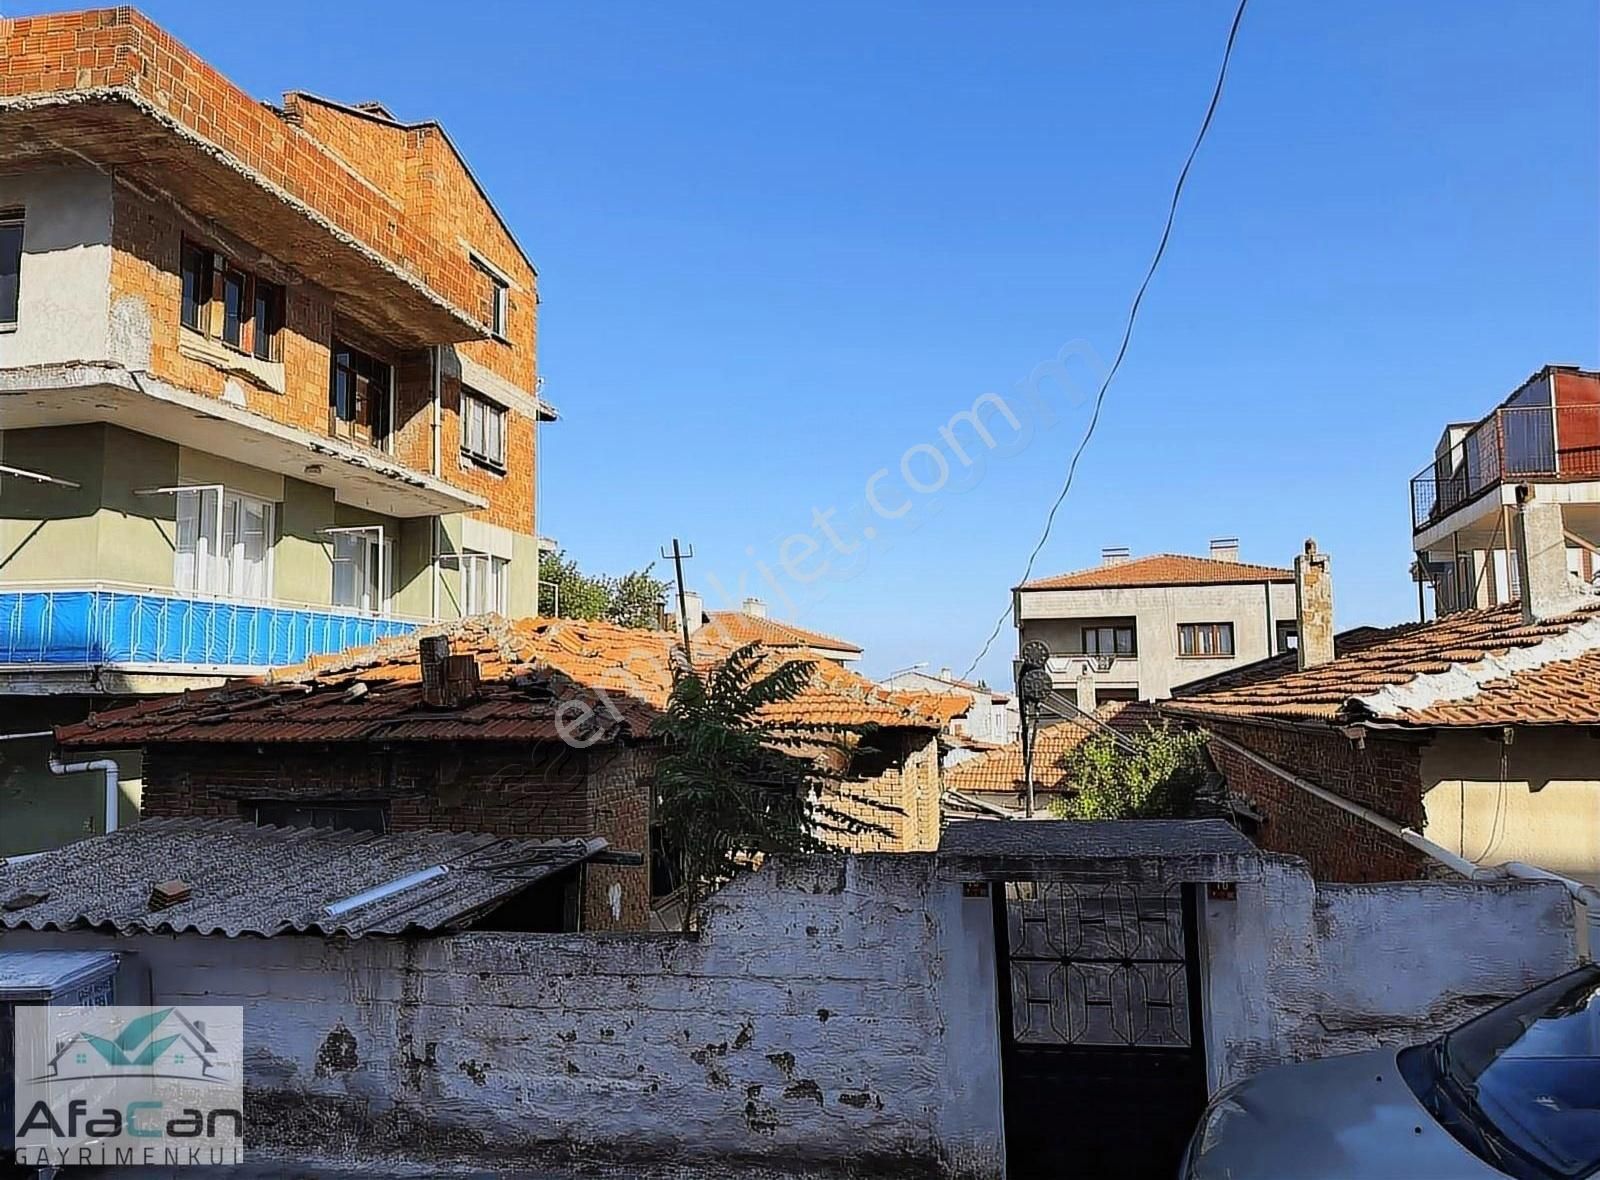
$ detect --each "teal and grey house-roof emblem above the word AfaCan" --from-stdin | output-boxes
[30,1007,232,1086]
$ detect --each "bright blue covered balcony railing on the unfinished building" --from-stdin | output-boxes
[0,585,422,670]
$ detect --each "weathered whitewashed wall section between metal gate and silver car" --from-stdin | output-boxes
[1202,857,1576,1086]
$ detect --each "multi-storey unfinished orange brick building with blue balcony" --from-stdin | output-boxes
[0,8,552,852]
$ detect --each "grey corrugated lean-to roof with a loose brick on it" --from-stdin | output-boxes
[0,819,606,939]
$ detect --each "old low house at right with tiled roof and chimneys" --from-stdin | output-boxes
[1160,527,1600,884]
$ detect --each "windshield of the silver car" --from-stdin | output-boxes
[1443,967,1600,1177]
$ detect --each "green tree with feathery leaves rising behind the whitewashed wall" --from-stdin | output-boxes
[653,644,886,931]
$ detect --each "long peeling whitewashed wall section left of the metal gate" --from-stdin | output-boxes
[0,855,1002,1177]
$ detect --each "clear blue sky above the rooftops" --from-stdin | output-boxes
[28,0,1600,680]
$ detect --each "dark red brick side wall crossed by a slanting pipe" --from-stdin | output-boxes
[1208,724,1424,881]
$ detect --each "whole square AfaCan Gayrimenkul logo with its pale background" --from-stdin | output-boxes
[13,1006,245,1167]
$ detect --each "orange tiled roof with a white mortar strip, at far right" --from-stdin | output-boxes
[1162,603,1600,726]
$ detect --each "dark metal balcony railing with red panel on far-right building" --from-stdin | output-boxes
[1411,406,1600,531]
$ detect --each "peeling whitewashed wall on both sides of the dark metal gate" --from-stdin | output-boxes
[0,855,1574,1177]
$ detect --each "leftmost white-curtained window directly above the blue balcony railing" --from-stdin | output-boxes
[173,486,275,600]
